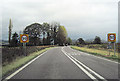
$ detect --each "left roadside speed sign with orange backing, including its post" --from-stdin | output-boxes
[20,34,29,56]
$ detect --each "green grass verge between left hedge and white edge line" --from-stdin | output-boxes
[2,47,51,76]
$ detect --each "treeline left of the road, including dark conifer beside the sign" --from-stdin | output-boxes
[10,22,72,46]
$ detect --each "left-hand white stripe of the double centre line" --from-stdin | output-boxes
[62,48,98,81]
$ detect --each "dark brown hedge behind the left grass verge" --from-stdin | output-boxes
[2,46,50,66]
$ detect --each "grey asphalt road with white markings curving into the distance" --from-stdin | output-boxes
[4,46,118,81]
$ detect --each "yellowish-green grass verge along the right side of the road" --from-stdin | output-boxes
[71,46,120,61]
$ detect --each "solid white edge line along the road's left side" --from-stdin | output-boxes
[6,51,47,79]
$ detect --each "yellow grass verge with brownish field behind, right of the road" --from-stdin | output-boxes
[71,44,120,61]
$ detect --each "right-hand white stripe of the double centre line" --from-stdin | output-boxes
[62,48,107,81]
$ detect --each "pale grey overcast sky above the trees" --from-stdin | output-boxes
[0,0,119,40]
